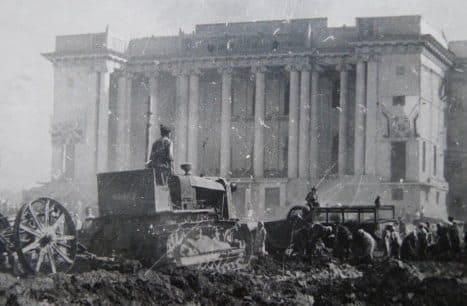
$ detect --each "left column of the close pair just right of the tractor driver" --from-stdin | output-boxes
[174,72,189,171]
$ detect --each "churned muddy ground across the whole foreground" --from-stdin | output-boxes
[0,257,467,306]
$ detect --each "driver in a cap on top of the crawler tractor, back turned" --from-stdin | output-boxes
[146,124,174,185]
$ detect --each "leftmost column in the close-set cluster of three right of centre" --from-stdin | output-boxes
[285,65,300,178]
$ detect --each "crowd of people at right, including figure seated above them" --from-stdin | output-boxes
[282,187,467,261]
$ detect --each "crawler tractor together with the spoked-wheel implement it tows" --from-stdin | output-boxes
[0,168,251,273]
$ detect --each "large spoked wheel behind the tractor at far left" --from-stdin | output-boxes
[14,198,78,274]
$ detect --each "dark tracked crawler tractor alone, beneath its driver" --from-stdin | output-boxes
[80,165,248,266]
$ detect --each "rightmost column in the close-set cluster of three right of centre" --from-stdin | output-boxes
[310,66,321,179]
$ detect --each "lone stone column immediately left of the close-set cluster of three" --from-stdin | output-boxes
[252,66,267,177]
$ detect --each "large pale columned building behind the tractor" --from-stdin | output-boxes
[44,16,455,218]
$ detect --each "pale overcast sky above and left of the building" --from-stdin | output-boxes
[0,0,467,190]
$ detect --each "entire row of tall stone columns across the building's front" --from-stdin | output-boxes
[115,58,377,178]
